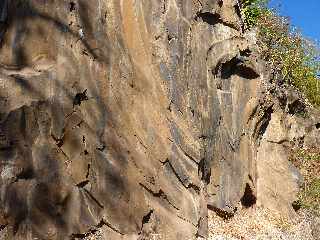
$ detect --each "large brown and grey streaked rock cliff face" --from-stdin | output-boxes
[0,0,319,240]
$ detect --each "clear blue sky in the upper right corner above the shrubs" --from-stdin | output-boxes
[270,0,320,42]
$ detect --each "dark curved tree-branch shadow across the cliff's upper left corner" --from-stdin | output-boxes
[0,1,109,69]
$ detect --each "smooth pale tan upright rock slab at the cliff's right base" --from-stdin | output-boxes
[257,113,299,216]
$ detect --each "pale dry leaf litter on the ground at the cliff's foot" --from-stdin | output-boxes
[209,209,314,240]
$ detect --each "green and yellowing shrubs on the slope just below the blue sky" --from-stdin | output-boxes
[242,0,320,106]
